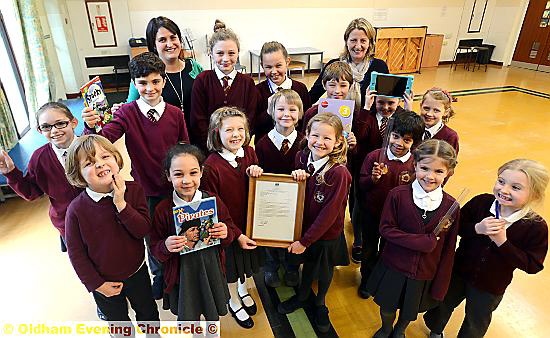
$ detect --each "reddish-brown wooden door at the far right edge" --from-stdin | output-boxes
[512,0,550,69]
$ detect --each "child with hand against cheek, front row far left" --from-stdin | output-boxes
[66,135,159,326]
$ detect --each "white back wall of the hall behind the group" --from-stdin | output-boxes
[52,0,528,93]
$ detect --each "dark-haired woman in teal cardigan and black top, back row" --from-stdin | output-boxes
[126,16,203,130]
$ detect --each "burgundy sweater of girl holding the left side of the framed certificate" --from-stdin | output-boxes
[200,146,258,233]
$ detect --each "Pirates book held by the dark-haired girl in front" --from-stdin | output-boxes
[173,197,220,255]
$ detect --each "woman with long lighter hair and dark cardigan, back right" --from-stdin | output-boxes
[309,18,389,110]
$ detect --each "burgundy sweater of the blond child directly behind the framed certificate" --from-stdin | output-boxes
[254,132,304,175]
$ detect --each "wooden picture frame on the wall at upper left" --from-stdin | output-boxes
[85,0,117,48]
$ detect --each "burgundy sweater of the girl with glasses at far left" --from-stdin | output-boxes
[5,143,82,237]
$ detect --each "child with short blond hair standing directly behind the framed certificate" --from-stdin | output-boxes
[255,89,304,288]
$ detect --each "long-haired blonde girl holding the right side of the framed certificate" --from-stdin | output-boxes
[278,113,351,332]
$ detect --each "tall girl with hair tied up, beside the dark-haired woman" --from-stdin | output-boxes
[190,28,258,152]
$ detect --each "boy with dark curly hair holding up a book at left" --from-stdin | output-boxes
[82,52,189,299]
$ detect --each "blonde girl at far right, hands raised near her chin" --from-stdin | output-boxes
[424,159,548,337]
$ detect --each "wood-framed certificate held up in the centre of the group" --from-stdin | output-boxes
[246,174,306,248]
